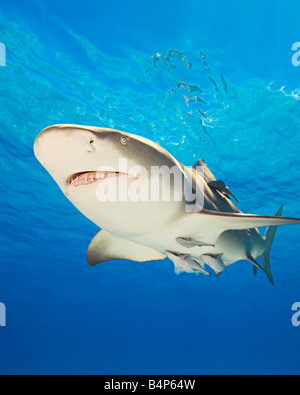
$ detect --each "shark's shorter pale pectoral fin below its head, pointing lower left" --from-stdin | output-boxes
[87,230,166,266]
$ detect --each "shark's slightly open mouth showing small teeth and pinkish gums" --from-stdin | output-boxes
[67,171,135,187]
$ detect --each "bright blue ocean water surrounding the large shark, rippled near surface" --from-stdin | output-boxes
[0,0,300,374]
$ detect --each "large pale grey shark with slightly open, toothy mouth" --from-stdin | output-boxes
[34,125,300,284]
